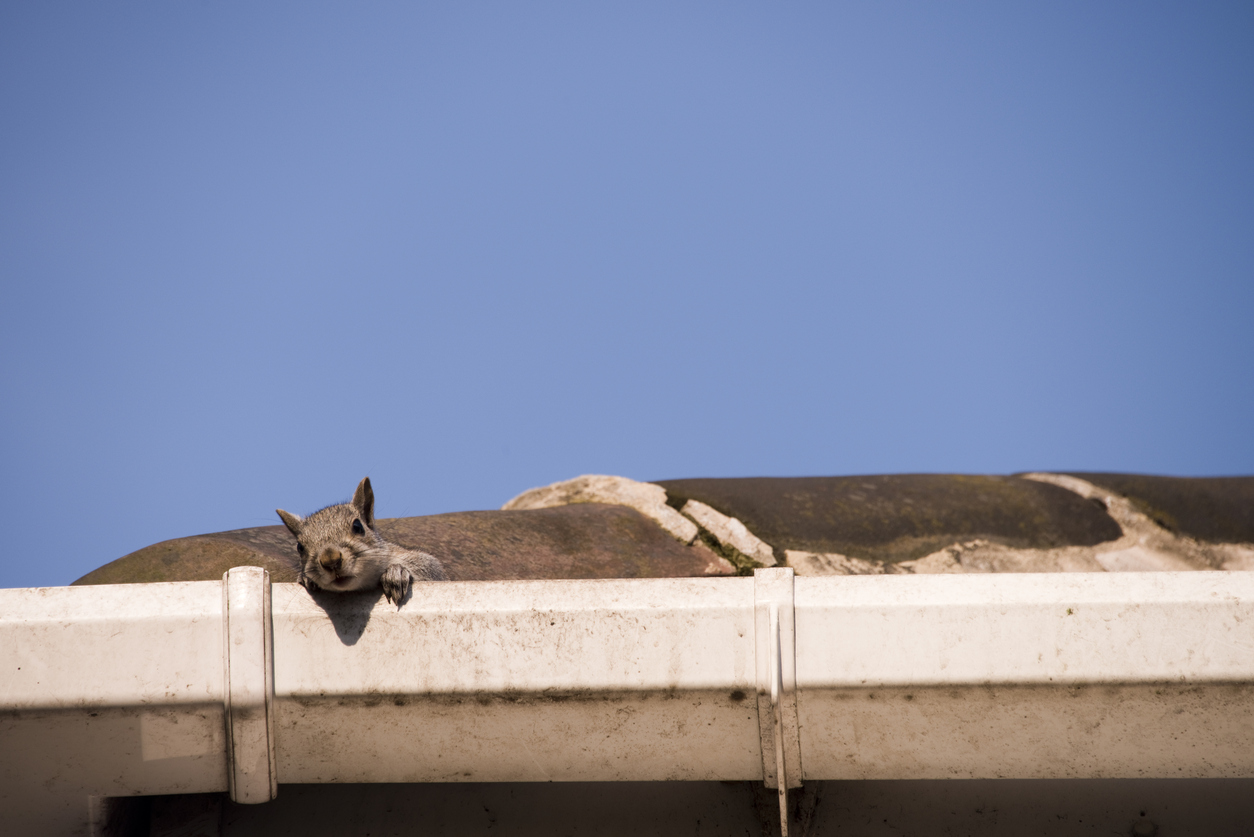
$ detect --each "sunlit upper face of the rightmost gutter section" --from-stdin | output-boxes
[796,572,1254,693]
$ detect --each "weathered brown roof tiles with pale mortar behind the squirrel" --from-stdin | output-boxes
[75,473,1254,585]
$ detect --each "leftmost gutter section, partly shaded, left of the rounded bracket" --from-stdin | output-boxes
[0,581,227,834]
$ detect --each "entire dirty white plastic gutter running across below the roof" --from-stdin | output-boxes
[0,567,1254,833]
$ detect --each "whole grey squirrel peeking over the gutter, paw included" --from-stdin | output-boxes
[275,477,449,607]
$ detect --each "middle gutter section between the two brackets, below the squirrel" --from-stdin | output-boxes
[273,578,762,782]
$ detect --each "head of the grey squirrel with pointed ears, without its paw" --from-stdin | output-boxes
[276,477,384,591]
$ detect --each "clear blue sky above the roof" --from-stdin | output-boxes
[0,1,1254,586]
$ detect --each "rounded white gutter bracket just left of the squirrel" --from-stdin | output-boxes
[222,567,278,804]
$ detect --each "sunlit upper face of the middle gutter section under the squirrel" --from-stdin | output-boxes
[273,578,755,699]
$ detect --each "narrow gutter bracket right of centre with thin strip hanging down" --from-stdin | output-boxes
[754,567,801,837]
